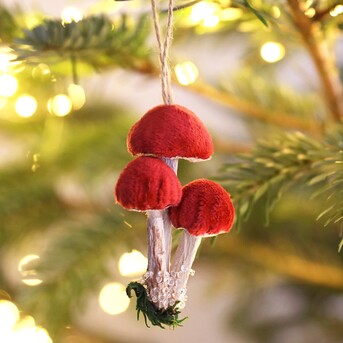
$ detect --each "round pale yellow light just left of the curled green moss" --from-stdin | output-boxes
[99,282,130,315]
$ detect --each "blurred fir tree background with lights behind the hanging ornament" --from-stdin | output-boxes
[0,0,343,343]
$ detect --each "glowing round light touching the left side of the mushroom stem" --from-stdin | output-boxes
[118,250,148,276]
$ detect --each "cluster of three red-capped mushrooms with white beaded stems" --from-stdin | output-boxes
[115,104,234,325]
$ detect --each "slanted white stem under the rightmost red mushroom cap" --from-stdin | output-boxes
[171,230,201,308]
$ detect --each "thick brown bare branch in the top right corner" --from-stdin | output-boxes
[287,0,343,121]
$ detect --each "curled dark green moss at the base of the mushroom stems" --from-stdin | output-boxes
[126,282,187,329]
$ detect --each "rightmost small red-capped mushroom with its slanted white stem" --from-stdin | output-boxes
[169,179,234,309]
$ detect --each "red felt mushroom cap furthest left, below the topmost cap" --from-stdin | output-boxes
[115,156,182,211]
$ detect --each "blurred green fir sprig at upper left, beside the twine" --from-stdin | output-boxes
[14,15,150,68]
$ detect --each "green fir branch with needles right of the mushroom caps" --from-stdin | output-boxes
[218,126,343,234]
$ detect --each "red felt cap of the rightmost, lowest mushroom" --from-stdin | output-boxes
[170,179,235,236]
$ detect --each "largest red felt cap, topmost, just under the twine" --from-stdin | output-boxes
[127,105,213,161]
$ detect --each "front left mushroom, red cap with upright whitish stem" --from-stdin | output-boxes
[115,156,182,309]
